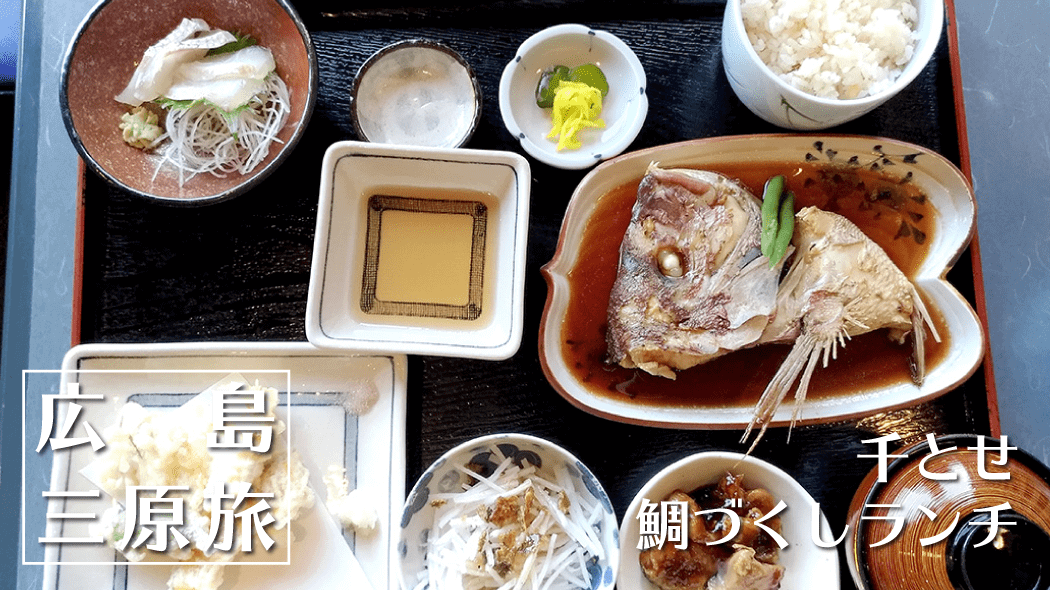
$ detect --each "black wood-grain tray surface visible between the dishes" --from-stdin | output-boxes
[75,0,989,587]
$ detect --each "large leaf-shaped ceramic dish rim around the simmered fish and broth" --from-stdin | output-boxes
[540,133,985,428]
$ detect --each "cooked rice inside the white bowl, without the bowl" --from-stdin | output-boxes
[740,0,919,99]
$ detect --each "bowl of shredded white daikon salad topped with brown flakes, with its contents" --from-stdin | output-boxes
[398,434,620,590]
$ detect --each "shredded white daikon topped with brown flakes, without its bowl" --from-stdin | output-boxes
[416,446,605,590]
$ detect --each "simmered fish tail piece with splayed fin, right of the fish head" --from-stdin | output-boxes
[742,207,940,452]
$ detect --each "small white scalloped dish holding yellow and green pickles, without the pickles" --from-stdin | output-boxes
[500,24,649,169]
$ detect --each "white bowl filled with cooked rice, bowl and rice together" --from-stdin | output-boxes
[721,0,944,130]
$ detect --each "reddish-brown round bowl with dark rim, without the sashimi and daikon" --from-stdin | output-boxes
[60,0,317,205]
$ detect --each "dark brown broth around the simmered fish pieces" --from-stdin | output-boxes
[562,163,948,407]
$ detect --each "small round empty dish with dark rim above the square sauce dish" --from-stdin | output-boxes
[351,39,481,147]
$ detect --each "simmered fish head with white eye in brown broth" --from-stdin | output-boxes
[607,164,780,379]
